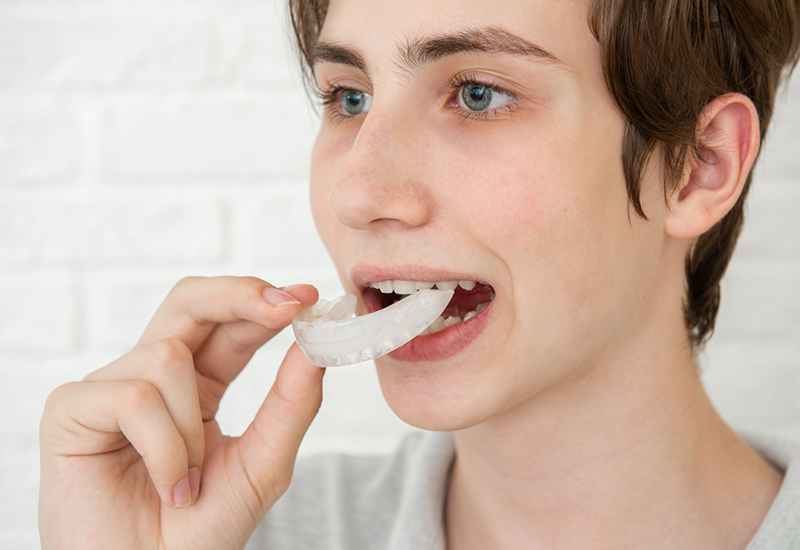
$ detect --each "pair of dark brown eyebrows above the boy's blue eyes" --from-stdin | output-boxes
[309,27,563,73]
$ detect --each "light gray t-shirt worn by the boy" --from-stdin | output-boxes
[246,432,800,550]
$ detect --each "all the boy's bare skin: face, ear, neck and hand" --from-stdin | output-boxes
[39,0,781,550]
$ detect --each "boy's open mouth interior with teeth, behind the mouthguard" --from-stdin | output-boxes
[362,280,495,336]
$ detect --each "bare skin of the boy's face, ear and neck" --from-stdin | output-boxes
[311,0,780,550]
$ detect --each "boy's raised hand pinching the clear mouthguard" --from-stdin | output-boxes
[39,277,324,550]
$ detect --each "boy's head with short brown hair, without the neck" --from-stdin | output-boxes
[290,0,800,429]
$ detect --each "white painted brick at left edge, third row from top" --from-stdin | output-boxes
[0,195,225,267]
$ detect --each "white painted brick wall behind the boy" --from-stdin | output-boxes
[0,0,800,549]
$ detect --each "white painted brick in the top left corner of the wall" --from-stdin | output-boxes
[0,2,213,87]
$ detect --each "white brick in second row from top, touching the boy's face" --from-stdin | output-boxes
[98,95,312,181]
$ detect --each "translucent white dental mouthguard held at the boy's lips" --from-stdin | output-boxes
[292,289,453,367]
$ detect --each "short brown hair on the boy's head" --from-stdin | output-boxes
[289,0,800,347]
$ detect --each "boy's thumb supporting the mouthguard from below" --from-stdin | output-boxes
[239,344,325,514]
